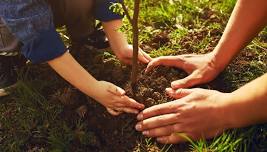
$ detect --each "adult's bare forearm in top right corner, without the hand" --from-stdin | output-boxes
[213,0,267,69]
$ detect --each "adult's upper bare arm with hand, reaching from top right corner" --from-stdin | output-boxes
[147,0,267,89]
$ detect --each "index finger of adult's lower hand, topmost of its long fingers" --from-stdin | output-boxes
[137,101,180,121]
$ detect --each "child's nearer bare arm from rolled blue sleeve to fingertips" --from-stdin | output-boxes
[48,52,144,115]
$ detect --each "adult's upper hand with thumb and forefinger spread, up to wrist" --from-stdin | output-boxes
[146,53,224,89]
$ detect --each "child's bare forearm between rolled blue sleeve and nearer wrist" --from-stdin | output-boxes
[48,52,97,97]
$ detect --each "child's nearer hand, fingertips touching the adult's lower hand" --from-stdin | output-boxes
[93,81,145,115]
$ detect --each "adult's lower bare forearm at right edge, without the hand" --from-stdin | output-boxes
[225,74,267,128]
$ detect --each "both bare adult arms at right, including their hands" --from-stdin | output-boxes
[136,0,267,143]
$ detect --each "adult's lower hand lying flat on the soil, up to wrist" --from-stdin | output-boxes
[136,88,231,143]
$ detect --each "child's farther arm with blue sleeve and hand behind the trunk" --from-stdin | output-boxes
[94,0,151,64]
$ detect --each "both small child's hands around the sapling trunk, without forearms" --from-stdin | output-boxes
[94,45,152,116]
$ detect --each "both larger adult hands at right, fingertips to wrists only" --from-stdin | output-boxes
[136,53,229,144]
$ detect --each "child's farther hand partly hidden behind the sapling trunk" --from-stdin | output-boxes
[114,45,152,64]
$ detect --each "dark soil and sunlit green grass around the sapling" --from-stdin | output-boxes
[0,0,267,152]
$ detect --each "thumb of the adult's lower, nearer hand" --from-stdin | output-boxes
[166,88,193,99]
